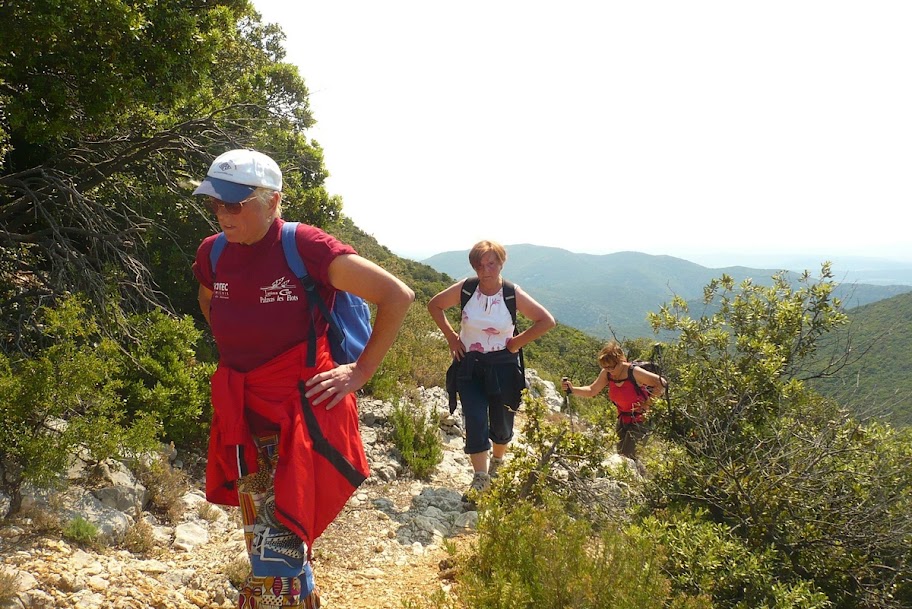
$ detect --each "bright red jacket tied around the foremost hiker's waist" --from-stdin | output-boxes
[206,337,369,547]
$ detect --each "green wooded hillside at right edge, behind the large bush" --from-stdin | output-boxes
[813,293,912,426]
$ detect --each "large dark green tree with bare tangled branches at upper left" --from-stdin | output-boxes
[0,0,341,353]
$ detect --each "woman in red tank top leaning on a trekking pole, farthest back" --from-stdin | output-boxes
[562,341,666,474]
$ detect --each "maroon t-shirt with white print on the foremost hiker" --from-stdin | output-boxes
[193,219,356,372]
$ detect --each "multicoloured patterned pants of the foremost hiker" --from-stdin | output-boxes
[238,435,320,609]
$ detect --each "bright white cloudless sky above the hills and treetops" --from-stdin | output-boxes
[253,0,912,264]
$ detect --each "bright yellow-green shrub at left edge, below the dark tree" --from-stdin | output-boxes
[0,298,158,512]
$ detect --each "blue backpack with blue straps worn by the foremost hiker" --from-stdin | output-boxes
[209,222,371,366]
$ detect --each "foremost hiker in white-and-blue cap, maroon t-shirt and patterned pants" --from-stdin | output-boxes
[193,149,414,608]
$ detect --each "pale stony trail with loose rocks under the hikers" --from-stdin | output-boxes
[0,380,560,609]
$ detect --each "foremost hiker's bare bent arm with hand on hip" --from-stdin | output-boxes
[305,254,415,409]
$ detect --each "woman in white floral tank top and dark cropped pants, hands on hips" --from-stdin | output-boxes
[428,241,555,500]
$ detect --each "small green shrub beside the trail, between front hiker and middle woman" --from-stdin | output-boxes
[390,402,443,479]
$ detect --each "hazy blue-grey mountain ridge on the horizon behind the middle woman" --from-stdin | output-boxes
[422,244,912,338]
